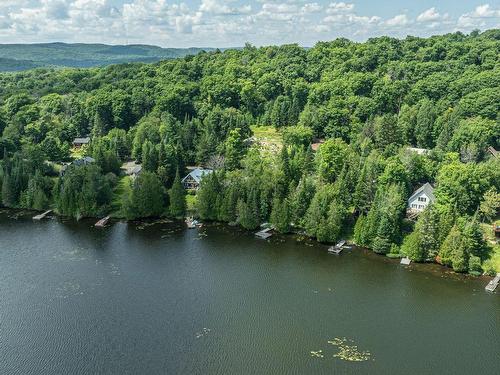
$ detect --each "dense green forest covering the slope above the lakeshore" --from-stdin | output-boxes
[0,30,500,274]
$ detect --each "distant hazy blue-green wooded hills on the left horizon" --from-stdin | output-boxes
[0,43,214,72]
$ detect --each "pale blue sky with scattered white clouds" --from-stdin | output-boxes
[0,0,500,48]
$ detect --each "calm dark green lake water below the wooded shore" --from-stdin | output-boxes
[0,213,500,375]
